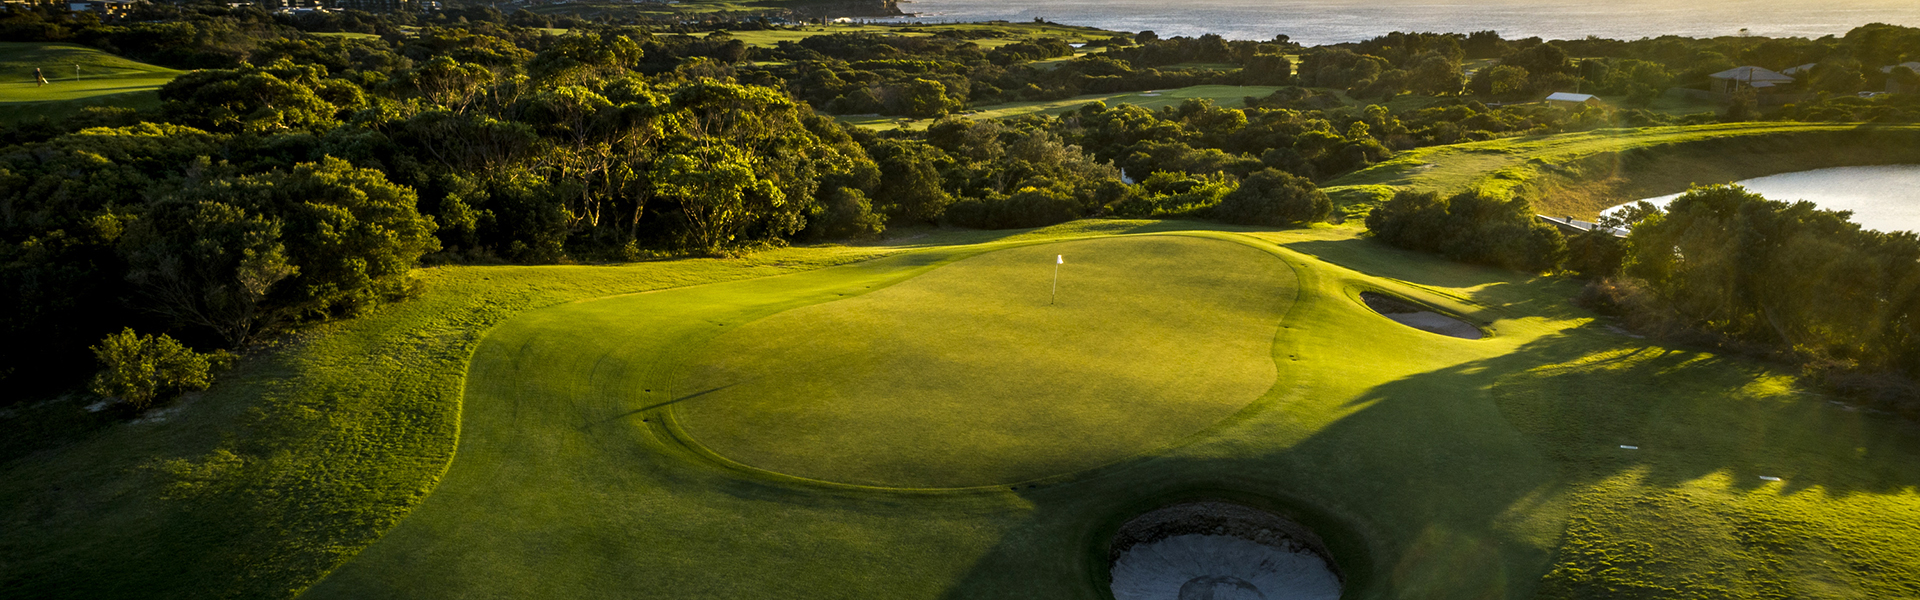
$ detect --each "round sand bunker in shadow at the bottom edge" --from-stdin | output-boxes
[1110,502,1340,600]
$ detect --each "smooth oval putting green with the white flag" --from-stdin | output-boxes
[672,237,1296,487]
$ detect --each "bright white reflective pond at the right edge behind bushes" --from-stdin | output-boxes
[1605,165,1920,231]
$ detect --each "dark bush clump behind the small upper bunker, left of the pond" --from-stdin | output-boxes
[1367,190,1567,273]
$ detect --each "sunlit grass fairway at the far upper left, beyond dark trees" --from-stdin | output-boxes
[0,42,182,121]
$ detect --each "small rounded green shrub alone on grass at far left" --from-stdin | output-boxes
[92,327,228,410]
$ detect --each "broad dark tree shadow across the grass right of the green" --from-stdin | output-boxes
[929,331,1920,598]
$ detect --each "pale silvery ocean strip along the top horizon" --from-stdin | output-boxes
[879,0,1920,46]
